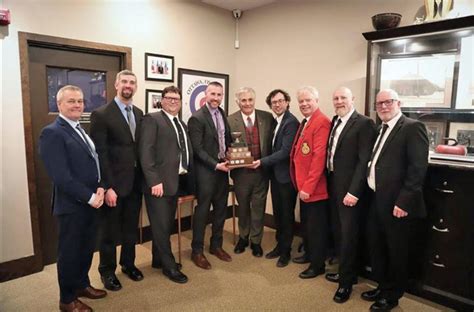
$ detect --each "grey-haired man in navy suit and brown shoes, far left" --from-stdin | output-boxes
[39,85,107,311]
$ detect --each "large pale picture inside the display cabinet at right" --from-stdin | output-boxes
[378,53,456,109]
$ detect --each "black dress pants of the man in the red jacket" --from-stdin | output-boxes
[300,200,329,270]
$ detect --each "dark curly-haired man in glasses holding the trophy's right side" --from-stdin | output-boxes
[253,89,300,267]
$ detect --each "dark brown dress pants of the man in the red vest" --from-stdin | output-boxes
[234,168,268,245]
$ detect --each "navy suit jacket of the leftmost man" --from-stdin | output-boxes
[39,117,99,215]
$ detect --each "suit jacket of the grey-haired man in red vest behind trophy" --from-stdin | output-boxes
[229,109,275,179]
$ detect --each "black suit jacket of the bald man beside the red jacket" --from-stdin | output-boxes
[331,111,375,202]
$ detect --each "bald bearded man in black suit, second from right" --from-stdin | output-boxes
[326,87,375,303]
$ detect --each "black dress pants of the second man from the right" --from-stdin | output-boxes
[328,175,363,288]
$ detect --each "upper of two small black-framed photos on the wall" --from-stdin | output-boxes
[145,53,174,81]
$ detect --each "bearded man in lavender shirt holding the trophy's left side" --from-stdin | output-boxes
[188,82,232,269]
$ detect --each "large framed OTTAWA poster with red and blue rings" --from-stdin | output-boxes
[178,68,229,123]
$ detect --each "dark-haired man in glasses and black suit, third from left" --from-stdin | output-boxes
[139,86,194,283]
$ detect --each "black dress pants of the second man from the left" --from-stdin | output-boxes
[99,191,142,275]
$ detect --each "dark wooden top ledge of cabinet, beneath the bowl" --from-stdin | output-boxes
[362,15,474,41]
